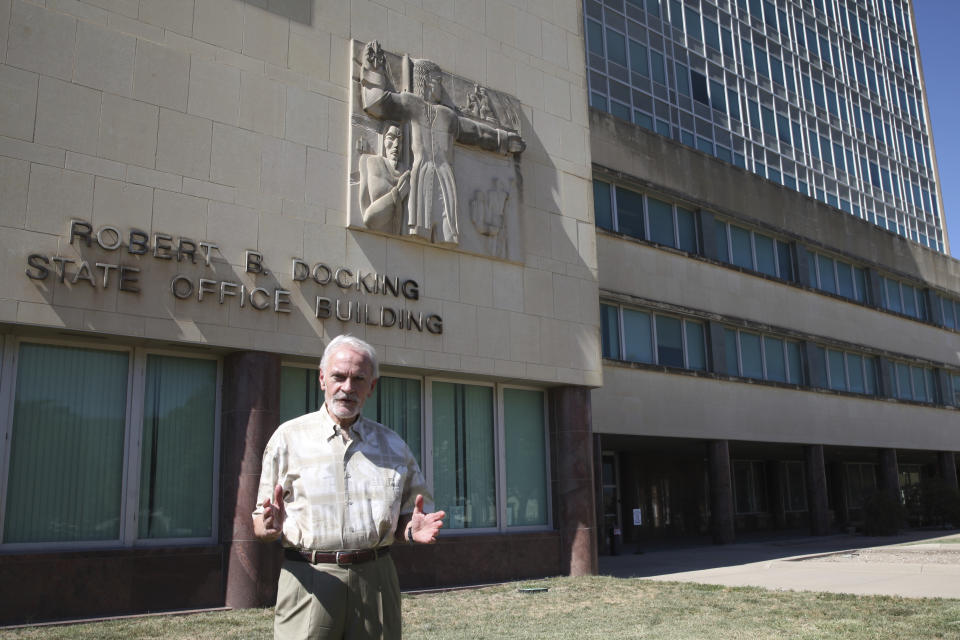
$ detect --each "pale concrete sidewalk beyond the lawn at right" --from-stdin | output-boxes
[600,532,960,598]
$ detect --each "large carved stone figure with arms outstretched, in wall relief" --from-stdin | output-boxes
[360,41,526,245]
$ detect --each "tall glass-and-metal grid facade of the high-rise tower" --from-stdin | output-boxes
[585,0,949,252]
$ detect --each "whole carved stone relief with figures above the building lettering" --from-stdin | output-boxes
[352,41,526,259]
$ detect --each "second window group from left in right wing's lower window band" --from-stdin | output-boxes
[723,327,804,385]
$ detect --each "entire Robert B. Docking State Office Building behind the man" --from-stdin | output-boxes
[0,0,960,624]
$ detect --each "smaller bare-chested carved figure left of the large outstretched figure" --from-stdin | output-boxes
[360,125,410,233]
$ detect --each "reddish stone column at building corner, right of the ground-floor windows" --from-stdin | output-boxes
[548,386,597,576]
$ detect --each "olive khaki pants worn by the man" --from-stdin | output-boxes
[273,556,401,640]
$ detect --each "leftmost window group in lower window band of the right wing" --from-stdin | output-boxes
[600,304,707,371]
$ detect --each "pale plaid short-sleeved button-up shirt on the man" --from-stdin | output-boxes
[253,407,432,551]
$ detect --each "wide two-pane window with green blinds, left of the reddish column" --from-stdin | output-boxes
[2,342,218,546]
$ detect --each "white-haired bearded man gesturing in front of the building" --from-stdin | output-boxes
[253,336,444,639]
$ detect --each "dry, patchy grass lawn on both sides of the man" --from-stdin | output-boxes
[0,577,960,640]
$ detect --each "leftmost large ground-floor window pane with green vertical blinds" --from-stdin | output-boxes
[3,343,129,544]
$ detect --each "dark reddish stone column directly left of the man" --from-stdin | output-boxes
[220,351,282,609]
